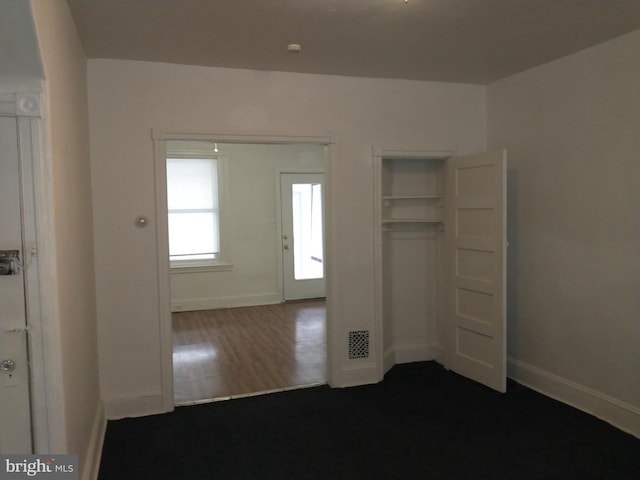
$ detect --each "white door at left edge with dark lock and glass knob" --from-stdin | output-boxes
[0,117,32,454]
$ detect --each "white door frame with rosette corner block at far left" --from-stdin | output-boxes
[0,88,65,453]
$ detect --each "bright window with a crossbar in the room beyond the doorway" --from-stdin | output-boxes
[167,141,228,268]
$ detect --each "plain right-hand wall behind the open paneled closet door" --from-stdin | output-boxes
[488,31,640,436]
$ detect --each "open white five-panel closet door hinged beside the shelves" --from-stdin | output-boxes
[445,151,506,392]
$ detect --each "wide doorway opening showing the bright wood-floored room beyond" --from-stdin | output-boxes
[156,135,328,405]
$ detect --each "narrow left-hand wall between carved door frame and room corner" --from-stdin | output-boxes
[32,0,106,478]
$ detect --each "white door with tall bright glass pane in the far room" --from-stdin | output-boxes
[280,173,325,300]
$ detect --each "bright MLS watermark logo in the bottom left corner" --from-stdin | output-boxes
[0,455,78,480]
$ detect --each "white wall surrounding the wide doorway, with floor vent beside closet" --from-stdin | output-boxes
[88,60,486,415]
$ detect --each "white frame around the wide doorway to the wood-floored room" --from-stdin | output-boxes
[151,128,338,406]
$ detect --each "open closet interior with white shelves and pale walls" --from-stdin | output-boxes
[379,158,445,372]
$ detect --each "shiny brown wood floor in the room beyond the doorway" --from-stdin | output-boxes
[172,300,326,405]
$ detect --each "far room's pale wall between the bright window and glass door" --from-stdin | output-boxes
[171,143,325,311]
